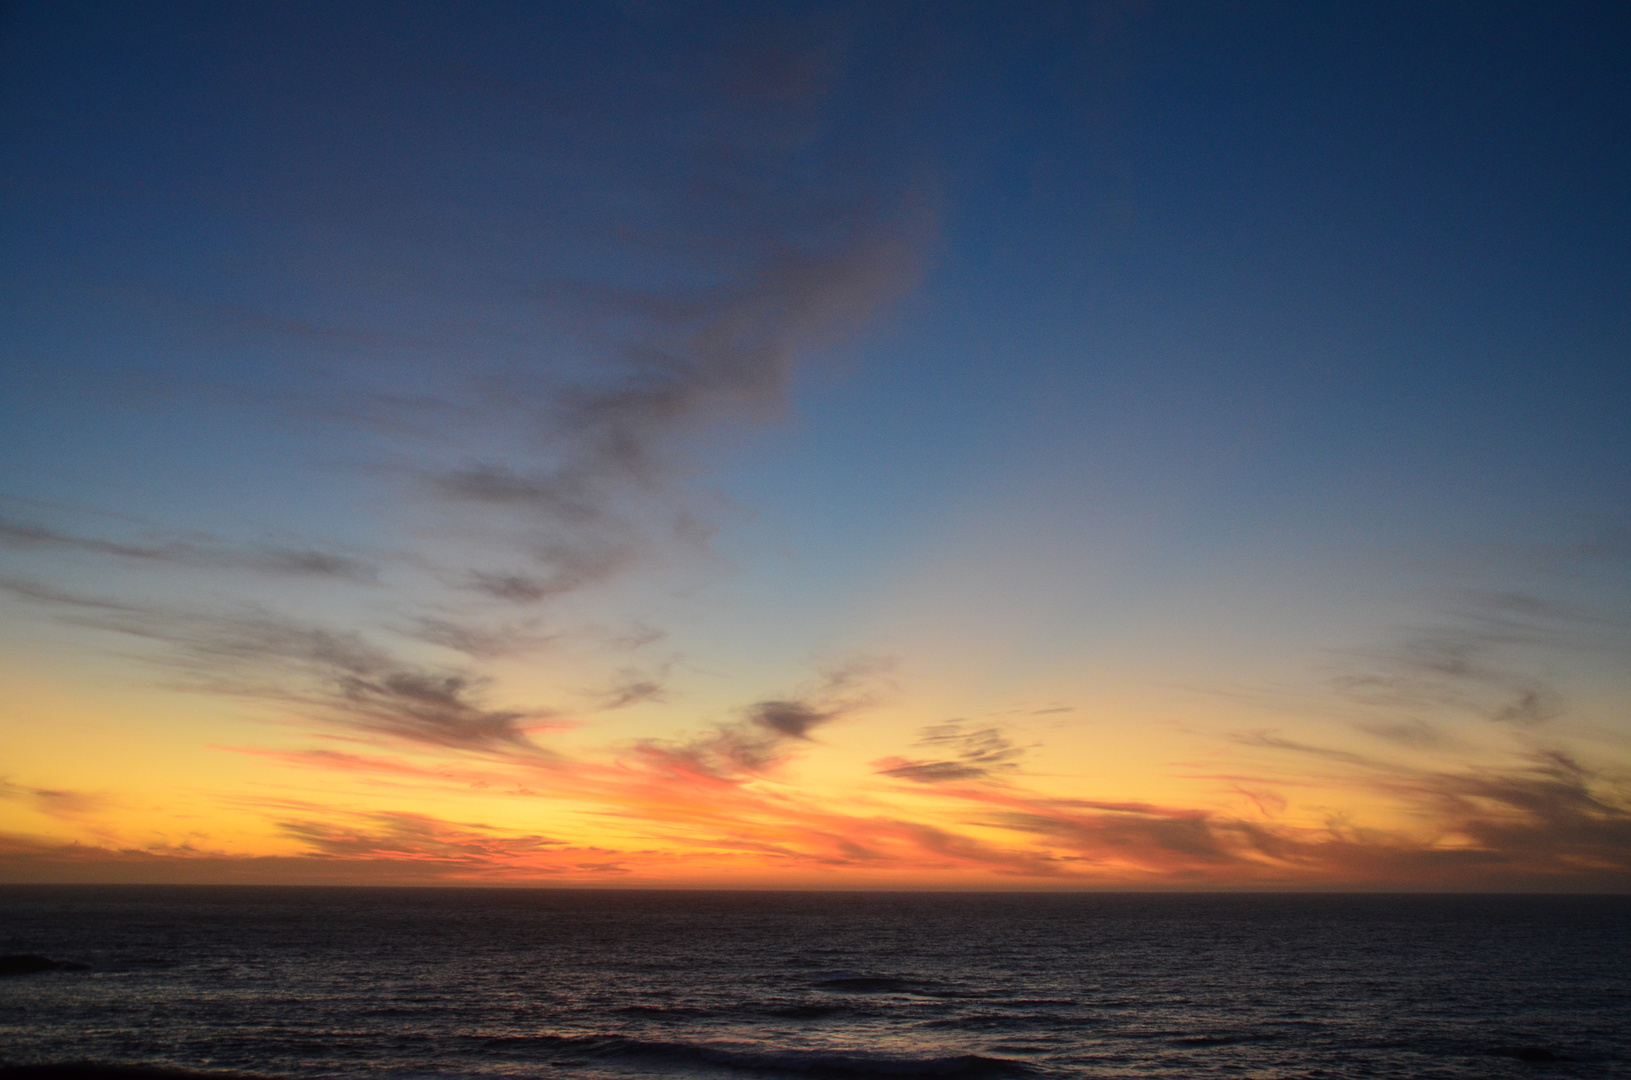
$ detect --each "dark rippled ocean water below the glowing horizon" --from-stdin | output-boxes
[0,887,1631,1080]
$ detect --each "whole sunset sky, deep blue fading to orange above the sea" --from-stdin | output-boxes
[0,0,1631,892]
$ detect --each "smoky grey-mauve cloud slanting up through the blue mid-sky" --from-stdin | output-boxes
[407,189,922,602]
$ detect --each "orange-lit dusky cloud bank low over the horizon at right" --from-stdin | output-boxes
[877,724,1631,889]
